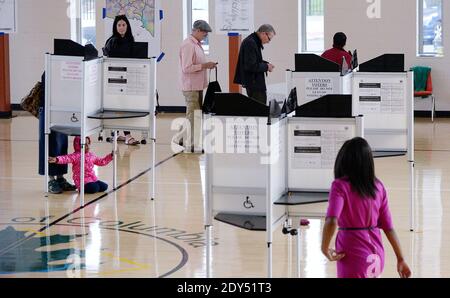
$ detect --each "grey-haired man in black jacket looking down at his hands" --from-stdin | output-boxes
[234,24,276,104]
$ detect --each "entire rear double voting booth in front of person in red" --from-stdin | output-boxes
[286,54,415,231]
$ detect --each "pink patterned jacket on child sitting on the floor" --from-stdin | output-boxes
[57,137,113,189]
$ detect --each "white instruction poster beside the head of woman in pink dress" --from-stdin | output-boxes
[290,124,354,169]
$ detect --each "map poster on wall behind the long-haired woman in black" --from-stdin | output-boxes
[105,0,161,57]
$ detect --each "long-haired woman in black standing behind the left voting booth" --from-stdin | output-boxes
[103,15,140,145]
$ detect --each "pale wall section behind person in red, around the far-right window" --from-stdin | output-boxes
[325,0,450,111]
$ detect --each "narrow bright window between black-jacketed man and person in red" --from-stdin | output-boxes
[299,0,325,53]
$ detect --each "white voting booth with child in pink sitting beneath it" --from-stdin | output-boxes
[45,46,156,206]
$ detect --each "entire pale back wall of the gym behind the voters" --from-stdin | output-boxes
[11,0,450,111]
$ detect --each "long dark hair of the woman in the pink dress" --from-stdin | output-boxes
[334,137,377,199]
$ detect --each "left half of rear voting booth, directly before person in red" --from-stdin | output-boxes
[286,54,353,105]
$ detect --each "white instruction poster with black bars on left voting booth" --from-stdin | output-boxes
[106,63,150,96]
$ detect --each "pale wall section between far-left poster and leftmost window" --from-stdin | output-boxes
[10,0,70,104]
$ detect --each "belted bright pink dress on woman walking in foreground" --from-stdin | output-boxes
[327,179,393,278]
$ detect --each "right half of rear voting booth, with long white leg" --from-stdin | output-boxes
[352,54,415,231]
